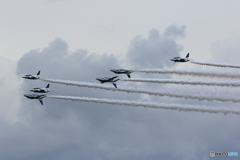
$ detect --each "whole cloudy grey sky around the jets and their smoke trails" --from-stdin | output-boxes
[0,0,240,160]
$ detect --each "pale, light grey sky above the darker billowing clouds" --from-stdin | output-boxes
[0,0,240,61]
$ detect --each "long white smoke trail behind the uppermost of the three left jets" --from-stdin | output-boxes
[41,78,240,103]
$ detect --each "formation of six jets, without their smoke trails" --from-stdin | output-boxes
[22,53,190,105]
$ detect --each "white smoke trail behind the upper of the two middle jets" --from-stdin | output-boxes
[135,69,240,78]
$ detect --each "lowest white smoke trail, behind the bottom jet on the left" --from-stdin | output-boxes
[47,95,240,114]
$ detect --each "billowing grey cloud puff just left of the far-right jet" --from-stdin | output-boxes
[126,25,185,69]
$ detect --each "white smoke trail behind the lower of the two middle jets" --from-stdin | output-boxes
[121,78,240,87]
